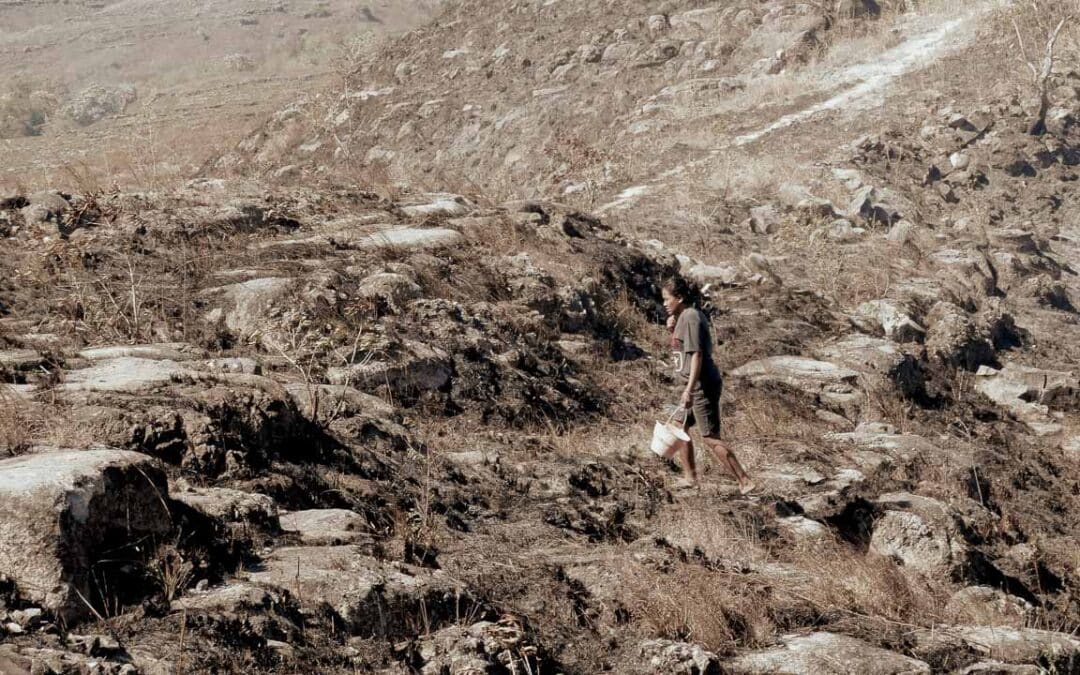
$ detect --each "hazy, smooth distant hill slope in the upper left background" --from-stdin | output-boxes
[0,0,433,187]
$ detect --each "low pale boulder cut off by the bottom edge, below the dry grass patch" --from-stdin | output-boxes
[724,633,930,675]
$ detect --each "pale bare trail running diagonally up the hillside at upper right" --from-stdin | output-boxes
[597,0,1000,214]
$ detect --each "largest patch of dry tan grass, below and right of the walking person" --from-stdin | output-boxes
[620,513,953,653]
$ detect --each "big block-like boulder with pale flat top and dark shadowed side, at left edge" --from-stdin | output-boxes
[0,448,172,622]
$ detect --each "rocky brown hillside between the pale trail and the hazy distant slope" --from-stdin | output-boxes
[225,0,941,200]
